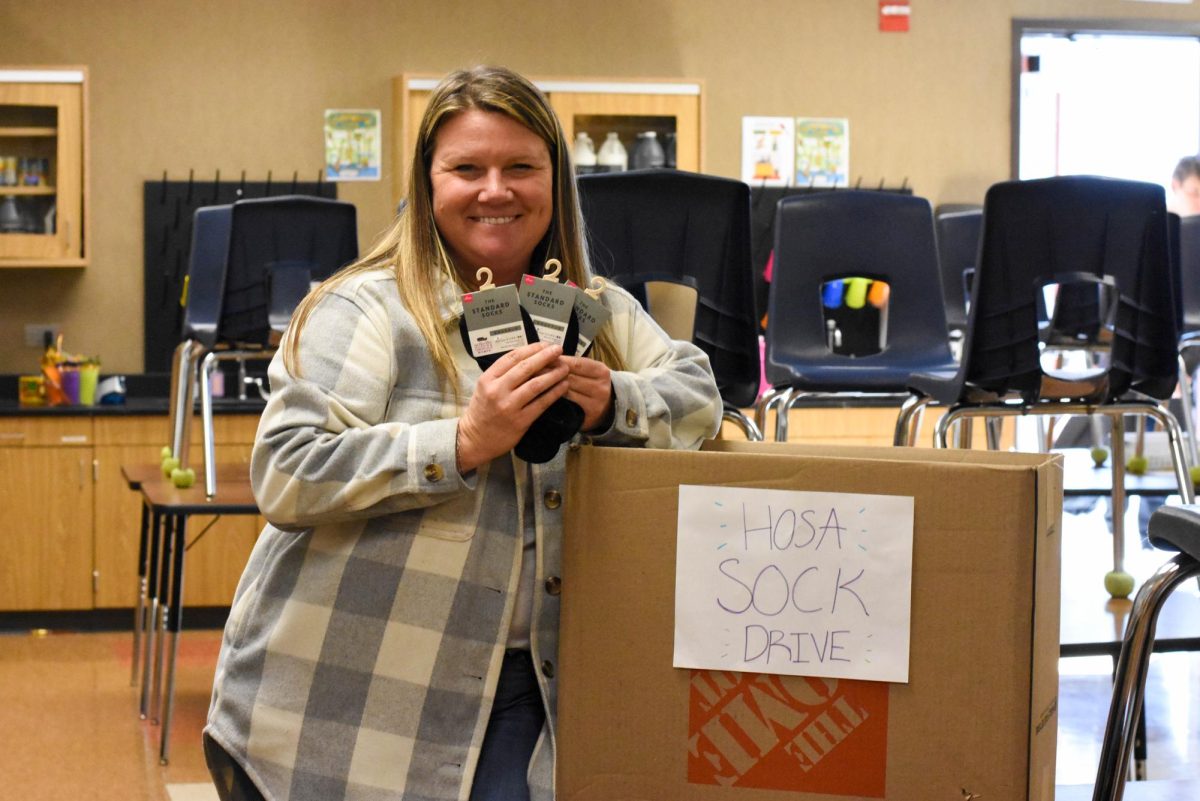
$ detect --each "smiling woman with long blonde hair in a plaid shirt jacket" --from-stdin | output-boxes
[205,67,721,801]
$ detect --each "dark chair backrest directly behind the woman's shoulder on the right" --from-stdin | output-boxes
[578,170,760,408]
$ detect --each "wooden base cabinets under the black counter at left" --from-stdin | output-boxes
[0,415,264,612]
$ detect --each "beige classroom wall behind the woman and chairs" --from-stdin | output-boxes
[0,0,1200,373]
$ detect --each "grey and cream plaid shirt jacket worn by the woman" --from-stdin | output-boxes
[205,270,721,801]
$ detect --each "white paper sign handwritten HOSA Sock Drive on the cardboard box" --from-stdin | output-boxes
[674,484,913,682]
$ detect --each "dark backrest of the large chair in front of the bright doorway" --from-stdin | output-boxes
[964,176,1177,401]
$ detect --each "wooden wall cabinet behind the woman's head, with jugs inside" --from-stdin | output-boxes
[392,74,704,205]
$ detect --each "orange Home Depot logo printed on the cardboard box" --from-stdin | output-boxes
[688,670,888,799]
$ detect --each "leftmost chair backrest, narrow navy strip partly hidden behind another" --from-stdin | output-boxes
[181,205,233,349]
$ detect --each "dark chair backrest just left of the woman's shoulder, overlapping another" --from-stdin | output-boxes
[218,195,359,345]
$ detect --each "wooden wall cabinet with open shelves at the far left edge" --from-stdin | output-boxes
[0,67,88,267]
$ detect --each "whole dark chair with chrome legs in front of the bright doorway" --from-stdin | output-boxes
[898,176,1193,582]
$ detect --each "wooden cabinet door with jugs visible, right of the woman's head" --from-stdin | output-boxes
[550,91,703,173]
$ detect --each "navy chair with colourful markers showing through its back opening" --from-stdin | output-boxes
[757,191,955,445]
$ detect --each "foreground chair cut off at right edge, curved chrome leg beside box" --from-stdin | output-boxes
[1092,506,1200,801]
